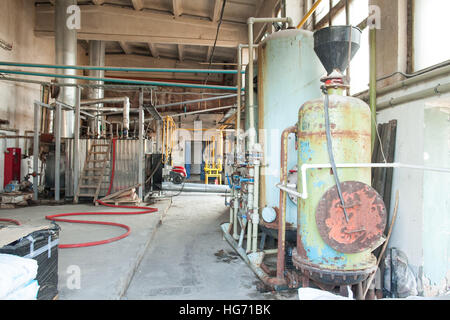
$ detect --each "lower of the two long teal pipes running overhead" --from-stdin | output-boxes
[0,69,236,91]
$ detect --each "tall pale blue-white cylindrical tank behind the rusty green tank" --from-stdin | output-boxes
[257,29,324,232]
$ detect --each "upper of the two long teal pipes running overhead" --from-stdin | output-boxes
[0,61,243,74]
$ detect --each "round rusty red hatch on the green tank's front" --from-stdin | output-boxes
[316,181,387,253]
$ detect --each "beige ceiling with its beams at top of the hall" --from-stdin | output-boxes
[35,0,278,67]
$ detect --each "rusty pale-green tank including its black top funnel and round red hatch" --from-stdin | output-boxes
[293,27,386,285]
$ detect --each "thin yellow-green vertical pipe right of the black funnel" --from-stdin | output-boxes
[369,27,377,152]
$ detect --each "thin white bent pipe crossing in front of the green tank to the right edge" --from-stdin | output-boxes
[276,162,450,199]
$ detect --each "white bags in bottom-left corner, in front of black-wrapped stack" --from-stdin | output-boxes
[0,253,39,300]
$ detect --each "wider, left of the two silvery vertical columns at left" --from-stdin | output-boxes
[55,0,77,138]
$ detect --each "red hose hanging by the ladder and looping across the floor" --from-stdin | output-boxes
[45,139,158,249]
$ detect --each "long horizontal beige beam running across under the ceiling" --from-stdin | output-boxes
[34,4,246,47]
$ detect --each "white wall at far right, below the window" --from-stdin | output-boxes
[377,77,450,295]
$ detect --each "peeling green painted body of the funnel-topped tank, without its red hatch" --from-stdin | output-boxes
[298,91,375,270]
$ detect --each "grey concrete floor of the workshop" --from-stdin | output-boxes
[0,194,297,300]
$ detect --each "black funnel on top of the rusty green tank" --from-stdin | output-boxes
[314,26,361,75]
